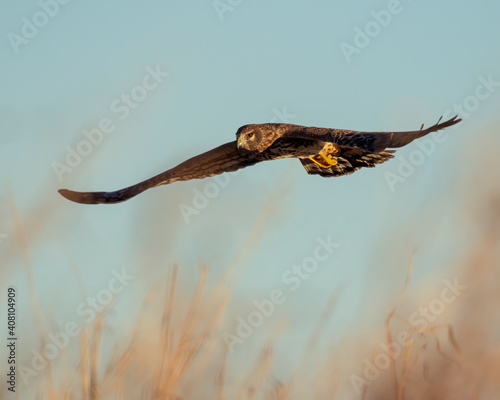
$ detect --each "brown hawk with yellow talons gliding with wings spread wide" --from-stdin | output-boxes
[59,116,461,204]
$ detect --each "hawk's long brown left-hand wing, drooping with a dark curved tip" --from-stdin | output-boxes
[59,141,261,204]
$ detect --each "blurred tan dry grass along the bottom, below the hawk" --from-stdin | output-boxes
[5,185,500,400]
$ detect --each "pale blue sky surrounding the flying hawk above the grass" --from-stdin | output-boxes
[0,0,500,394]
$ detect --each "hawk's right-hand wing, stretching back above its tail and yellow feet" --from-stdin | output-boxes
[283,115,461,153]
